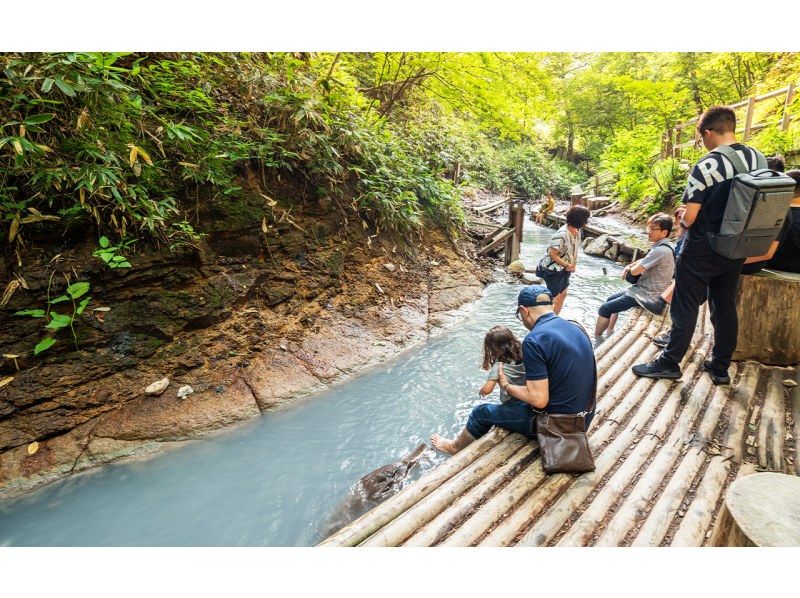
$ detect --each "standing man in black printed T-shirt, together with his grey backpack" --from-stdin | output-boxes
[632,106,791,384]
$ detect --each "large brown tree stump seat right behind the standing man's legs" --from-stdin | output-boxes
[733,270,800,365]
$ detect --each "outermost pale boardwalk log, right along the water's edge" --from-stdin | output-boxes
[319,428,510,546]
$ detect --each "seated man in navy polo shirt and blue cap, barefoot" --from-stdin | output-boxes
[431,285,595,455]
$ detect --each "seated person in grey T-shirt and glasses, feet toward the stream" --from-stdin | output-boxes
[594,213,675,348]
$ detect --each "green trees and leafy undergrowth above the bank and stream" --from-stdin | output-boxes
[0,52,800,252]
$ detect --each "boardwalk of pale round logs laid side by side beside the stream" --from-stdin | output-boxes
[320,308,800,546]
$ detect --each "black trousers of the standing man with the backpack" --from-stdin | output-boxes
[661,247,744,371]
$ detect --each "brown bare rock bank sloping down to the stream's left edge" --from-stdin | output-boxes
[0,205,487,495]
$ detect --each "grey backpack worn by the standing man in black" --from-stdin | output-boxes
[708,145,795,259]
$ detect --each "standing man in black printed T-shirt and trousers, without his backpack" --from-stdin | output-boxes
[632,106,766,384]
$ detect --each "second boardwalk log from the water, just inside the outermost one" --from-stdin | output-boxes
[361,434,527,546]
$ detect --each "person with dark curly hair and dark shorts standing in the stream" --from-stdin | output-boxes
[536,206,591,315]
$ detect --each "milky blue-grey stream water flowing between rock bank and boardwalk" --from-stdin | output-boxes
[0,220,626,546]
